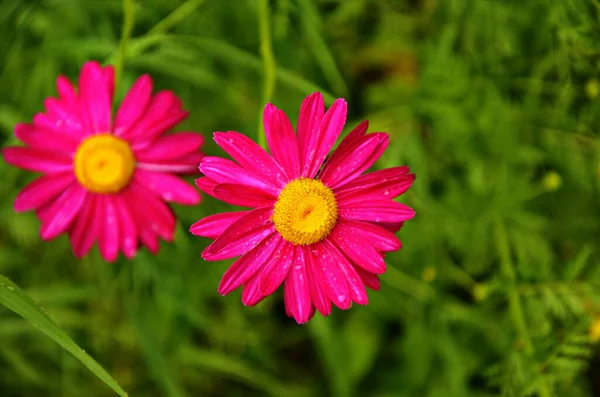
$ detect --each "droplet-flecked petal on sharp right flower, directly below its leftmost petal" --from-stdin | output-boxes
[202,208,275,260]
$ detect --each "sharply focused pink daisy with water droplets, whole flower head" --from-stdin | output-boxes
[190,93,415,323]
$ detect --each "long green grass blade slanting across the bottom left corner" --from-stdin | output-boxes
[0,275,127,397]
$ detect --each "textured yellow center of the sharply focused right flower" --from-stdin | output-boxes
[273,178,338,245]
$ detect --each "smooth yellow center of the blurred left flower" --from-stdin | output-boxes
[74,134,135,193]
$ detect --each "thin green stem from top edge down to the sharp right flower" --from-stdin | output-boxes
[258,0,275,149]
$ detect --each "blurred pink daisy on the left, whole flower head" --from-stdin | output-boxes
[2,62,203,261]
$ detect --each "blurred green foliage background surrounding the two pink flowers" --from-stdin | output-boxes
[0,0,600,397]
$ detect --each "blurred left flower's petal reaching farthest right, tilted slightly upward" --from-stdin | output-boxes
[135,132,204,165]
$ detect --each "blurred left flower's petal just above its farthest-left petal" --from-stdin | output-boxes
[15,123,79,153]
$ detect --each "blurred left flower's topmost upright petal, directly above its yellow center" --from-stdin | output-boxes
[79,61,113,132]
